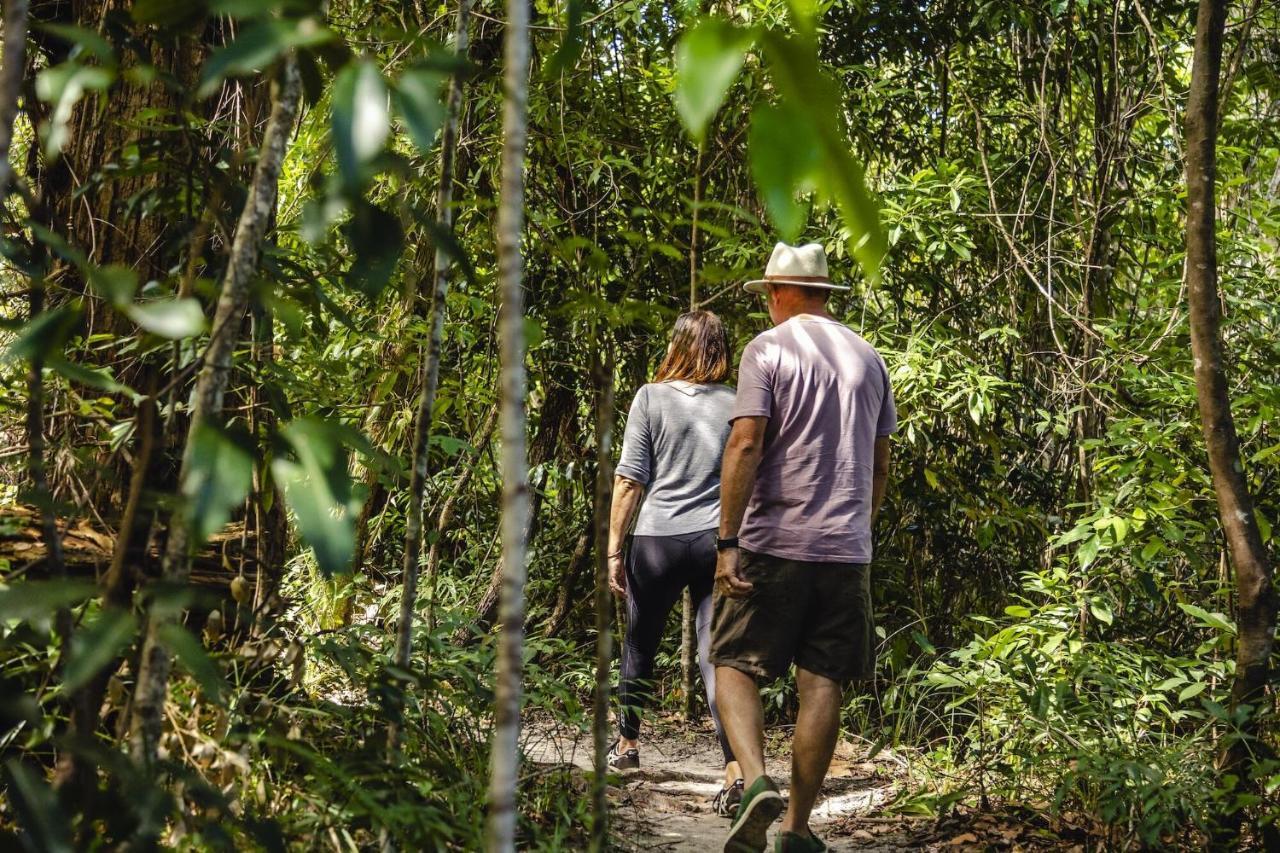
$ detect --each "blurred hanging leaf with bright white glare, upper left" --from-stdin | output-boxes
[333,60,390,192]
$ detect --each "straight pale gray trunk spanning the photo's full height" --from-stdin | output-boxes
[485,0,529,853]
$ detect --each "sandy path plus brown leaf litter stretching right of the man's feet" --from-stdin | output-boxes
[525,720,1083,853]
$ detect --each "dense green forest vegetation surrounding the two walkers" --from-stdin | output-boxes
[0,0,1280,849]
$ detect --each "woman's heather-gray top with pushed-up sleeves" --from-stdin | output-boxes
[614,382,733,537]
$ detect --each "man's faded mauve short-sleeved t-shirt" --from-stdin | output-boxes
[733,315,897,562]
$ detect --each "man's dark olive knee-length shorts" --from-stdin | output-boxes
[710,549,876,681]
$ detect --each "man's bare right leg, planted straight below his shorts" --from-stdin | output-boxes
[778,666,841,835]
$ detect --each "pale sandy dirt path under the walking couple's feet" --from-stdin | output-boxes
[526,721,928,853]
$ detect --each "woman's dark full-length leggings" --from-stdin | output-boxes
[618,529,733,763]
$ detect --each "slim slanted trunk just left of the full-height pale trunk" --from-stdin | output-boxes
[389,0,471,749]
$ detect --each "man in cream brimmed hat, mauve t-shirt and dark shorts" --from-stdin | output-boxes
[710,243,897,853]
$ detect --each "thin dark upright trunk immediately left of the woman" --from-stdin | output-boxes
[590,353,613,853]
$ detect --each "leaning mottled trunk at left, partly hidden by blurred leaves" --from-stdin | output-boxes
[131,55,302,766]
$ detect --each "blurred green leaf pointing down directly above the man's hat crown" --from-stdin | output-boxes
[748,104,820,241]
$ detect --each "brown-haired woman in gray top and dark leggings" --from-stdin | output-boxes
[608,311,742,817]
